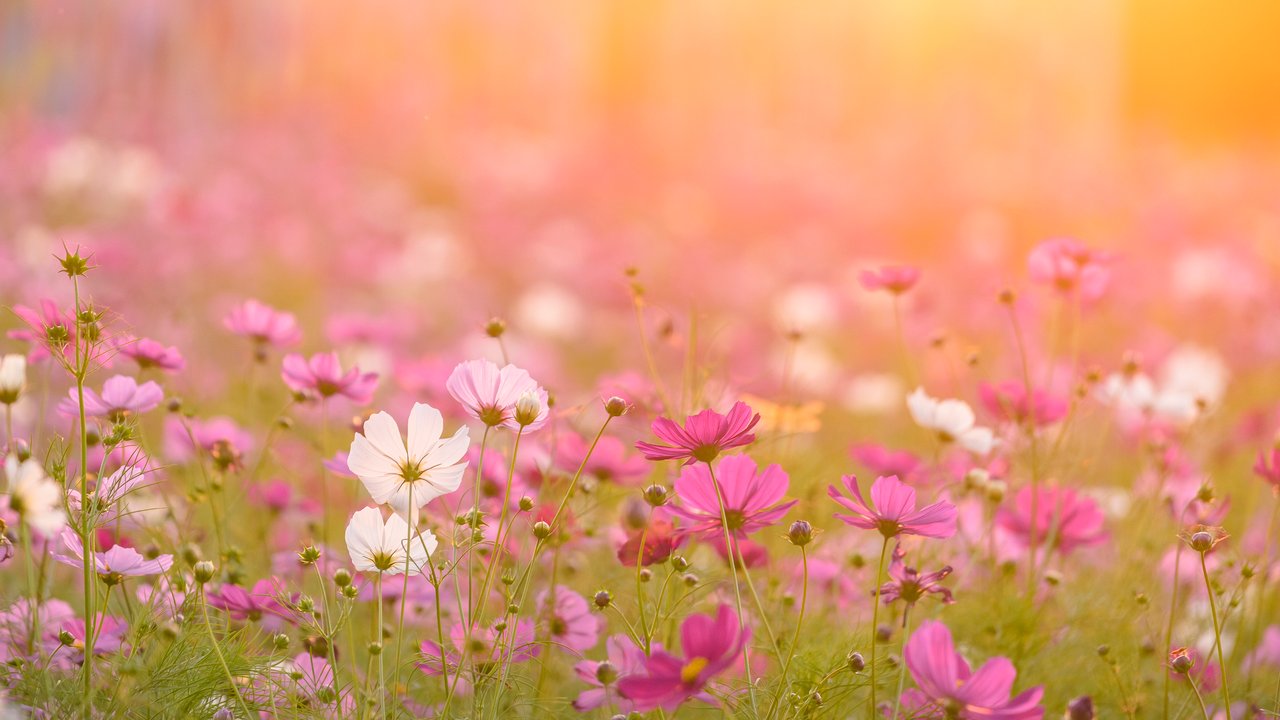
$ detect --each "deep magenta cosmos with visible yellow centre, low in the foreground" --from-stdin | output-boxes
[618,605,751,712]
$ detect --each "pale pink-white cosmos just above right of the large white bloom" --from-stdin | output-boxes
[444,360,547,432]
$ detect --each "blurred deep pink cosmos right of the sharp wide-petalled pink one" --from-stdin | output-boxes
[996,487,1107,555]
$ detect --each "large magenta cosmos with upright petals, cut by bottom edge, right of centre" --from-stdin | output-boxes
[902,620,1044,720]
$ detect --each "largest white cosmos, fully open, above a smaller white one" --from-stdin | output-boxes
[347,402,471,512]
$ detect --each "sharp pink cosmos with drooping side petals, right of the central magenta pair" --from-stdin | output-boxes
[827,475,956,538]
